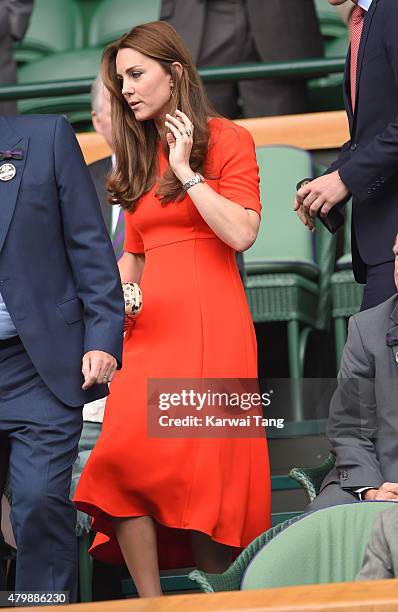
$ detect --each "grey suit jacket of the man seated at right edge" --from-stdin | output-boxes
[321,294,398,491]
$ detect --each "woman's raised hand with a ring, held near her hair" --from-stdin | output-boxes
[165,109,193,182]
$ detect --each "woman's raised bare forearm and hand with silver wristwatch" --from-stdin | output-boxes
[166,110,260,251]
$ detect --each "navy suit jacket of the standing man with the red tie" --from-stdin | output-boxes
[328,0,398,282]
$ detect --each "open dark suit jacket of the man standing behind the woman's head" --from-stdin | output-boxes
[161,0,323,62]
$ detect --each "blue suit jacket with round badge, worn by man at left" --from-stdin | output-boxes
[0,115,124,406]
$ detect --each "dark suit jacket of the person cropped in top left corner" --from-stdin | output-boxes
[0,0,33,113]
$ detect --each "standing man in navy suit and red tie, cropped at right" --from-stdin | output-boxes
[296,0,398,310]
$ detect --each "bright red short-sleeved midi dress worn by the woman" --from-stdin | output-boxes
[74,118,271,568]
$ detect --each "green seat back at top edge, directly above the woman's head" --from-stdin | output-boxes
[89,0,161,47]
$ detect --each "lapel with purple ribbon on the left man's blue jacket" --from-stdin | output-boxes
[0,117,29,253]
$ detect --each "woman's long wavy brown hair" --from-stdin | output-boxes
[101,21,217,211]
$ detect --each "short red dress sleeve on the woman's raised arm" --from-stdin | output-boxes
[211,122,261,214]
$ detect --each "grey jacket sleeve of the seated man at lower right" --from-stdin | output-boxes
[327,317,384,489]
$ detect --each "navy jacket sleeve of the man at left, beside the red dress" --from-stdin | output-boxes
[54,117,124,366]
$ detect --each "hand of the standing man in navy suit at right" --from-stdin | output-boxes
[295,170,350,222]
